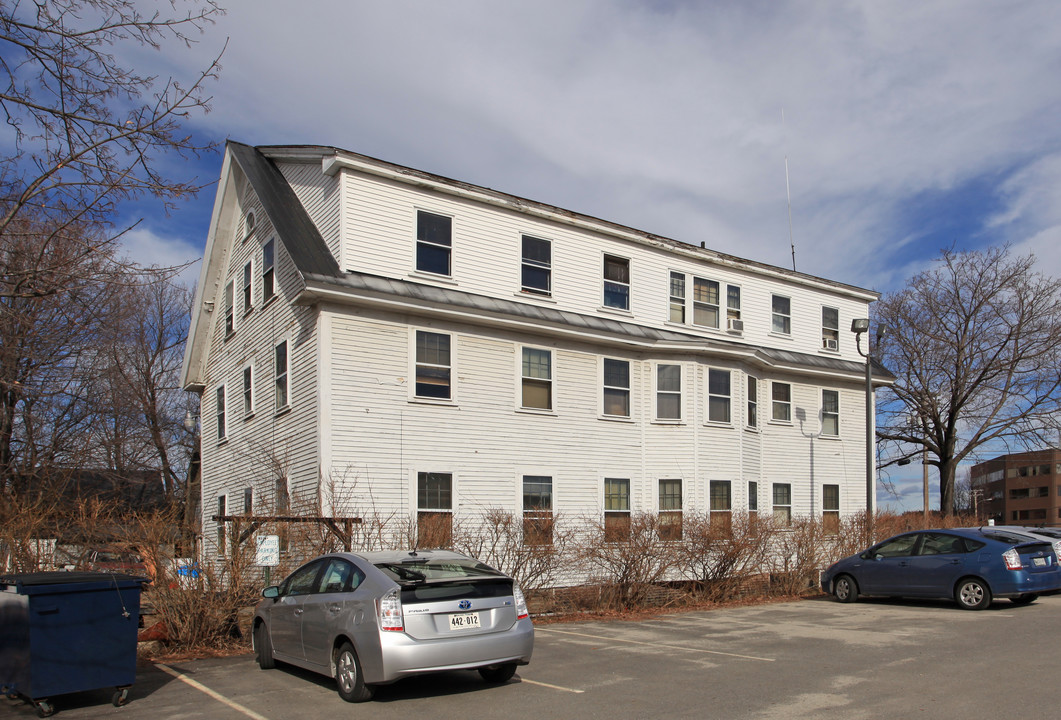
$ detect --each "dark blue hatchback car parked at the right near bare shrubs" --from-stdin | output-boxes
[821,527,1061,610]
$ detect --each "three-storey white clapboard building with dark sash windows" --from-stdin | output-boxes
[182,142,891,555]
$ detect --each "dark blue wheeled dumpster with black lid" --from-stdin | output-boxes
[0,573,147,717]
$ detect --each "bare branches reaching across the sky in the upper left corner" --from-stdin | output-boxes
[0,0,223,297]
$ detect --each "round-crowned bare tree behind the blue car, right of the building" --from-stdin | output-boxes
[876,247,1061,515]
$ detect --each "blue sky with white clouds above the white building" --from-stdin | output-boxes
[111,0,1061,509]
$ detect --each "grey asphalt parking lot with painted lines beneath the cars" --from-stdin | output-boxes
[8,596,1061,720]
